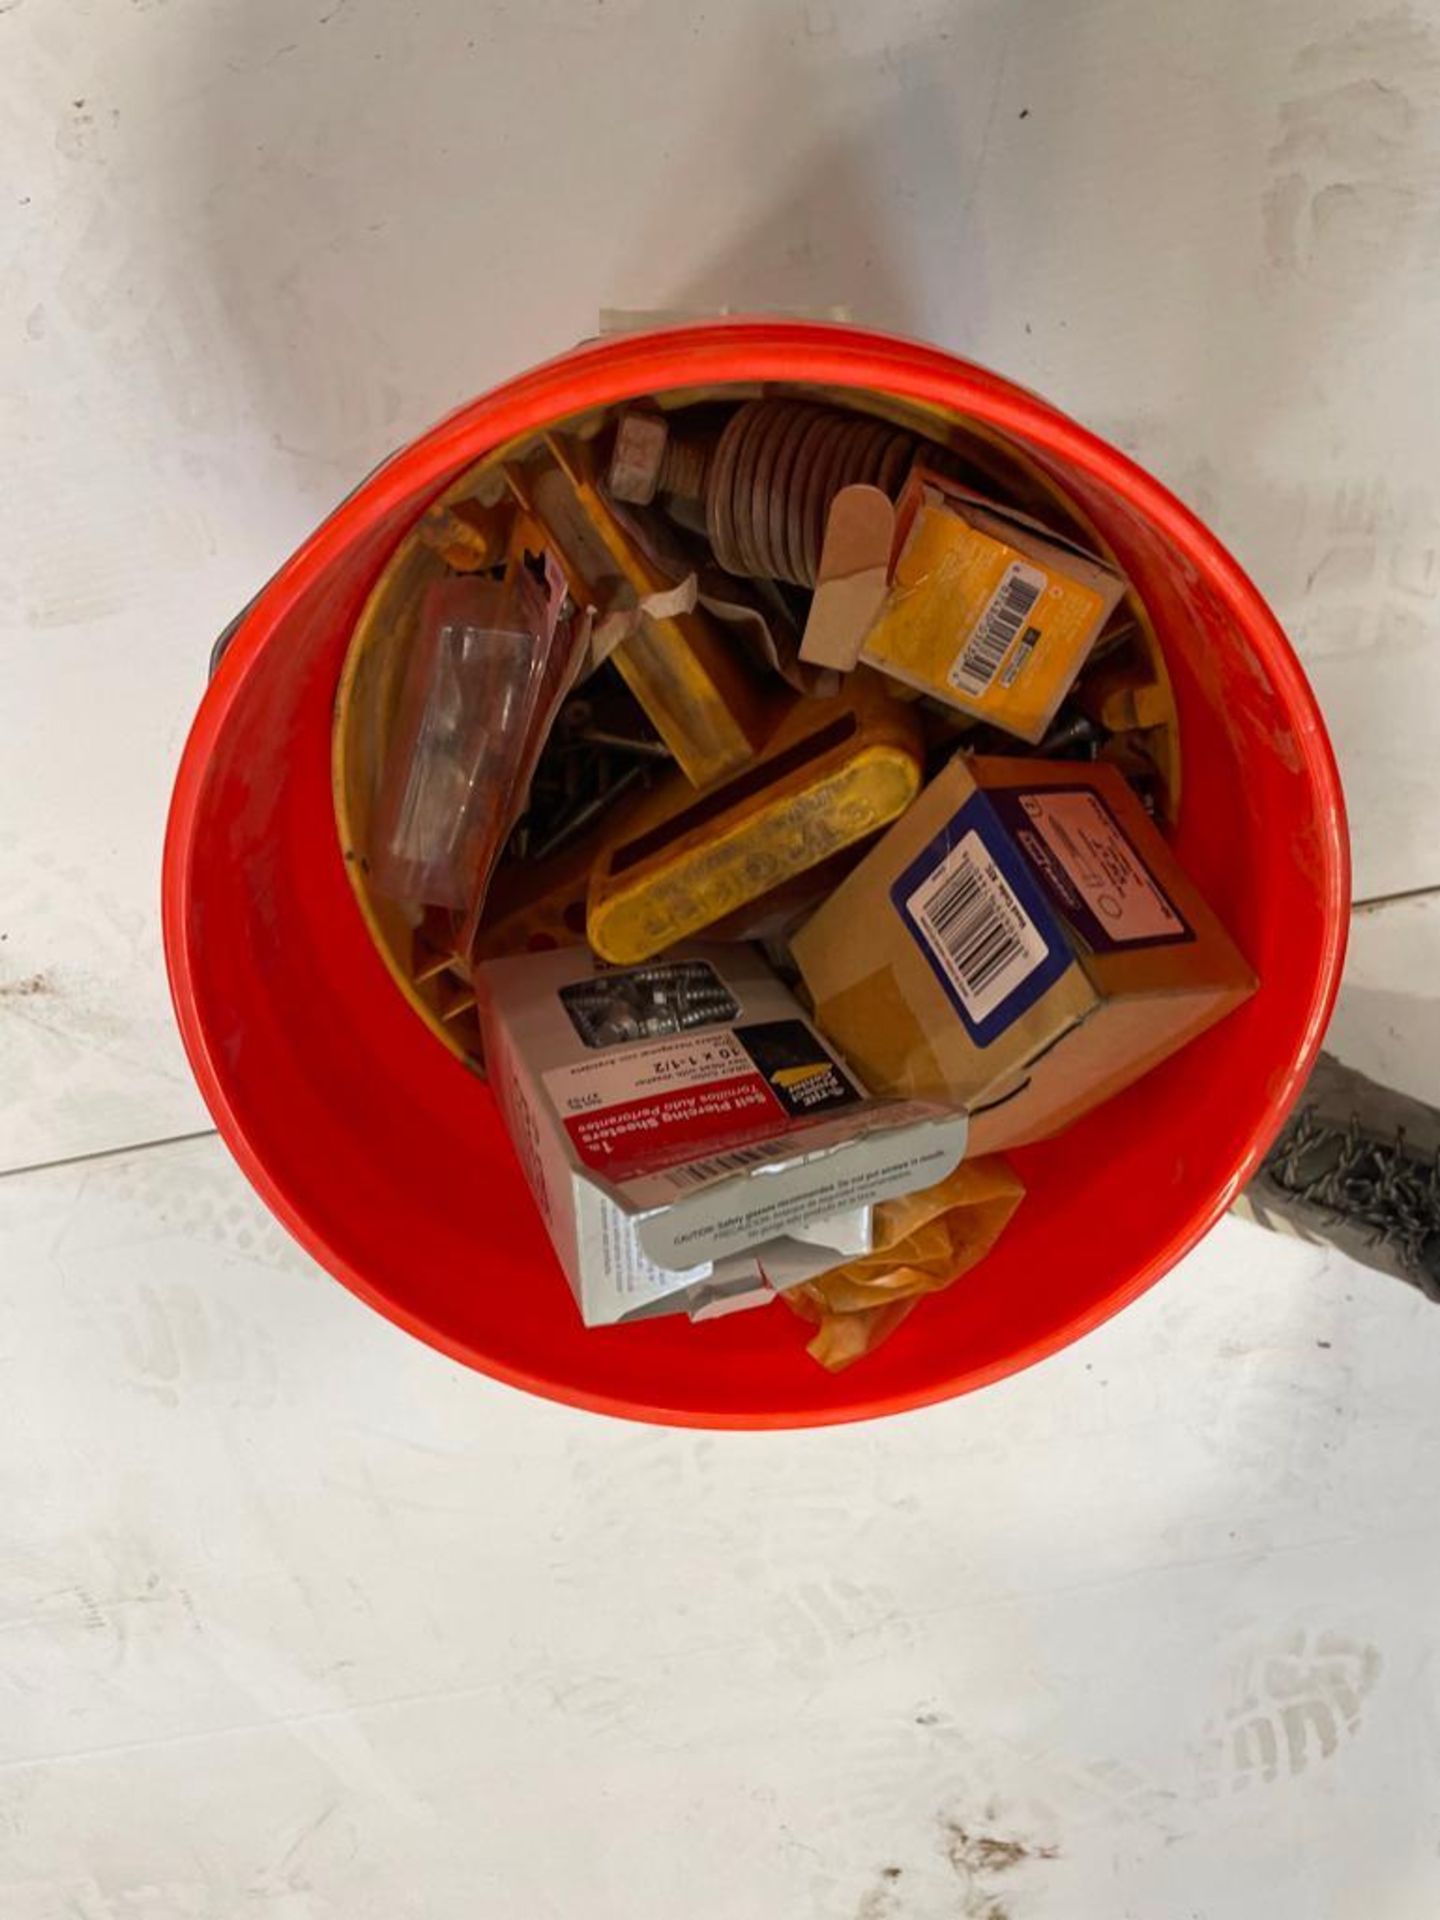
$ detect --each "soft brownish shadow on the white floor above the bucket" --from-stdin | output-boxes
[138,0,1440,537]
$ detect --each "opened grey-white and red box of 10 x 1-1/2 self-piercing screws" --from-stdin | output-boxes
[474,945,966,1327]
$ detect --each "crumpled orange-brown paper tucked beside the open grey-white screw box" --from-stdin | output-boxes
[783,1156,1025,1373]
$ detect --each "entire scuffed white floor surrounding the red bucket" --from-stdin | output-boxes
[0,0,1440,1920]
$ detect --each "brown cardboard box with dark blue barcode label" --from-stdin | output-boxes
[793,758,1256,1154]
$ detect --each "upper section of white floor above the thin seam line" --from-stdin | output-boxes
[0,0,1440,1167]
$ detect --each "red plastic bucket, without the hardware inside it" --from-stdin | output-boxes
[163,321,1348,1427]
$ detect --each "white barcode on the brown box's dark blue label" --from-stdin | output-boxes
[904,829,1050,1025]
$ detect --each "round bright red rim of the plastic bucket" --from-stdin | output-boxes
[161,319,1350,1430]
